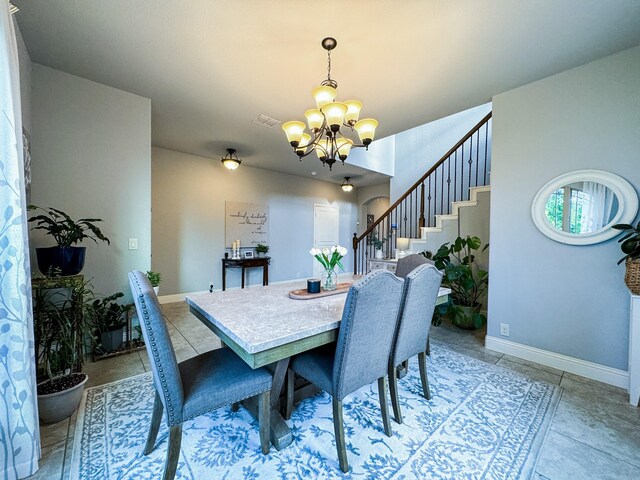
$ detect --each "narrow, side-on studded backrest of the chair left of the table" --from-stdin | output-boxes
[129,270,184,426]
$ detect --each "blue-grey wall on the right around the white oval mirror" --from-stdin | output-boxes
[488,47,640,370]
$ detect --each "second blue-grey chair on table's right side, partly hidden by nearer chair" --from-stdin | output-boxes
[388,265,442,423]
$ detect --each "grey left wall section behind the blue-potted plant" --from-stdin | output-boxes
[31,63,151,299]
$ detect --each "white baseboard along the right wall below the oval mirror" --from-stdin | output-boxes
[484,335,629,390]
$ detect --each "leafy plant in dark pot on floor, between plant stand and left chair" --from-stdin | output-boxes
[84,292,129,354]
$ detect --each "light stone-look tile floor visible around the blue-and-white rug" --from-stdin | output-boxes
[30,303,640,480]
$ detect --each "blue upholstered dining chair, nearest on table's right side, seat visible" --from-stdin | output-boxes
[285,270,403,472]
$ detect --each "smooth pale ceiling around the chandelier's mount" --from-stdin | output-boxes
[12,0,640,185]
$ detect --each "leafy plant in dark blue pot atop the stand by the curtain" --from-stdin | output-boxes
[28,205,110,275]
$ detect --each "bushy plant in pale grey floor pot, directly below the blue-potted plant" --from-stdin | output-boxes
[33,278,91,423]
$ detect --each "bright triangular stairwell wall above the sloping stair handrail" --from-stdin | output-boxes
[391,103,491,203]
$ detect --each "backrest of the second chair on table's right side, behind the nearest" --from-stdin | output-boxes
[391,265,442,366]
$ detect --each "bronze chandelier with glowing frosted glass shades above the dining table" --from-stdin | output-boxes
[282,37,378,170]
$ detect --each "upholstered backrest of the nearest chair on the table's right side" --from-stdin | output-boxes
[332,270,403,400]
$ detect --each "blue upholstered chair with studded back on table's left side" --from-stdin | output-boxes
[129,271,272,480]
